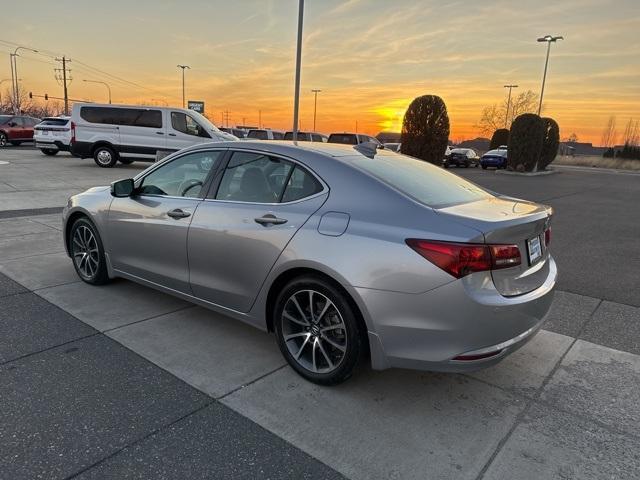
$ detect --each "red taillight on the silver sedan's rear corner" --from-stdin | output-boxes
[406,238,521,278]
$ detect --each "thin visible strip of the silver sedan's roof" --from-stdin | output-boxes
[176,140,398,158]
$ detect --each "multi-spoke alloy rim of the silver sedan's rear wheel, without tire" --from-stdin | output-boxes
[281,290,347,373]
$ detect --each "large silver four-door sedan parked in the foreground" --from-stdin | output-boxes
[63,141,557,384]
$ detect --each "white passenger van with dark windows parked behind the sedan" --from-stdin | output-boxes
[71,103,238,168]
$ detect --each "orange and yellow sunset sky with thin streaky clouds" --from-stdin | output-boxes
[0,0,640,144]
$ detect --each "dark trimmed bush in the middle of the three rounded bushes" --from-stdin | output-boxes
[507,113,544,172]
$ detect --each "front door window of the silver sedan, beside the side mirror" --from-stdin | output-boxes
[139,151,224,198]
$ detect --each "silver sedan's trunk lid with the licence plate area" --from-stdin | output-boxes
[436,197,553,296]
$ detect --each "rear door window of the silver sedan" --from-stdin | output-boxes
[216,152,293,203]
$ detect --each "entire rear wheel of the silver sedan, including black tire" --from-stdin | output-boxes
[273,275,364,385]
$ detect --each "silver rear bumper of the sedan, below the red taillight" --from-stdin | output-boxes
[357,257,557,372]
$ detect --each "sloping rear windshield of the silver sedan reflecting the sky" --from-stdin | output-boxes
[345,154,491,208]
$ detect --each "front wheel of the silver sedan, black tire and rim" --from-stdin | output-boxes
[68,217,109,285]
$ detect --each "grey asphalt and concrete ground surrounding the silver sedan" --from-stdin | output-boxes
[0,147,640,479]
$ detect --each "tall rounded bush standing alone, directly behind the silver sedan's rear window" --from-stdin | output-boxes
[400,95,449,165]
